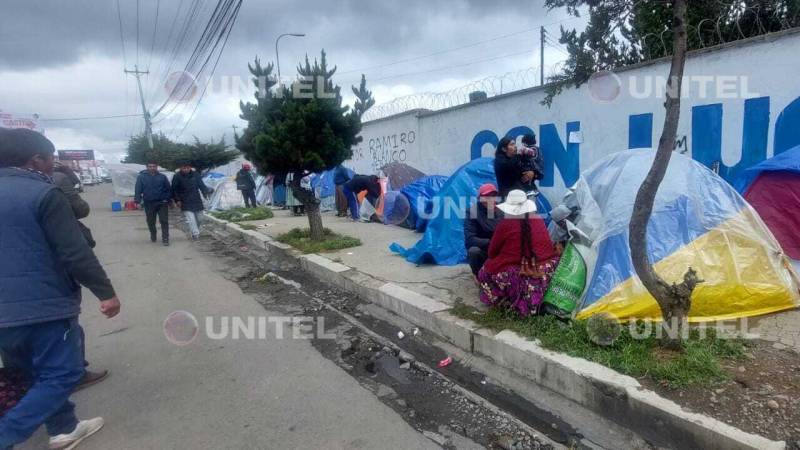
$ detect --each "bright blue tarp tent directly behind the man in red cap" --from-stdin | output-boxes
[389,158,550,266]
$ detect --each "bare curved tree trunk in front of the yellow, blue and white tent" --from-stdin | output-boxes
[628,0,702,349]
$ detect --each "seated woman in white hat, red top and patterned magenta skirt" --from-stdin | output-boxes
[478,189,559,316]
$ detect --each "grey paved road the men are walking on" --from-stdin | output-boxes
[21,185,436,449]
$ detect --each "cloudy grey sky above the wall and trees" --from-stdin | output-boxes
[0,0,581,160]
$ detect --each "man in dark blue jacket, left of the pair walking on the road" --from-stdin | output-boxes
[133,162,172,246]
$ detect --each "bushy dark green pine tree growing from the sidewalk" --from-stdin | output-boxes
[237,50,366,240]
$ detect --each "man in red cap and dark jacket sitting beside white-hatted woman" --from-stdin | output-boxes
[464,183,503,277]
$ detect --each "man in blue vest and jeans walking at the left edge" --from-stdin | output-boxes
[0,129,120,450]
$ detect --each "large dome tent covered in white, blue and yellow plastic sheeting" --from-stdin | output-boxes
[576,150,799,322]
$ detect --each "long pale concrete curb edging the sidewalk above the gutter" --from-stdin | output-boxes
[209,216,786,450]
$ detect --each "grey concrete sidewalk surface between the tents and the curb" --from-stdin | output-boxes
[246,209,800,352]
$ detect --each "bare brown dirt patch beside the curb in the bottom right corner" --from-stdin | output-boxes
[639,341,800,450]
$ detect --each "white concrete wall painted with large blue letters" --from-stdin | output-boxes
[348,32,800,202]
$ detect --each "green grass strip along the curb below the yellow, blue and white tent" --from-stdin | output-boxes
[451,303,746,388]
